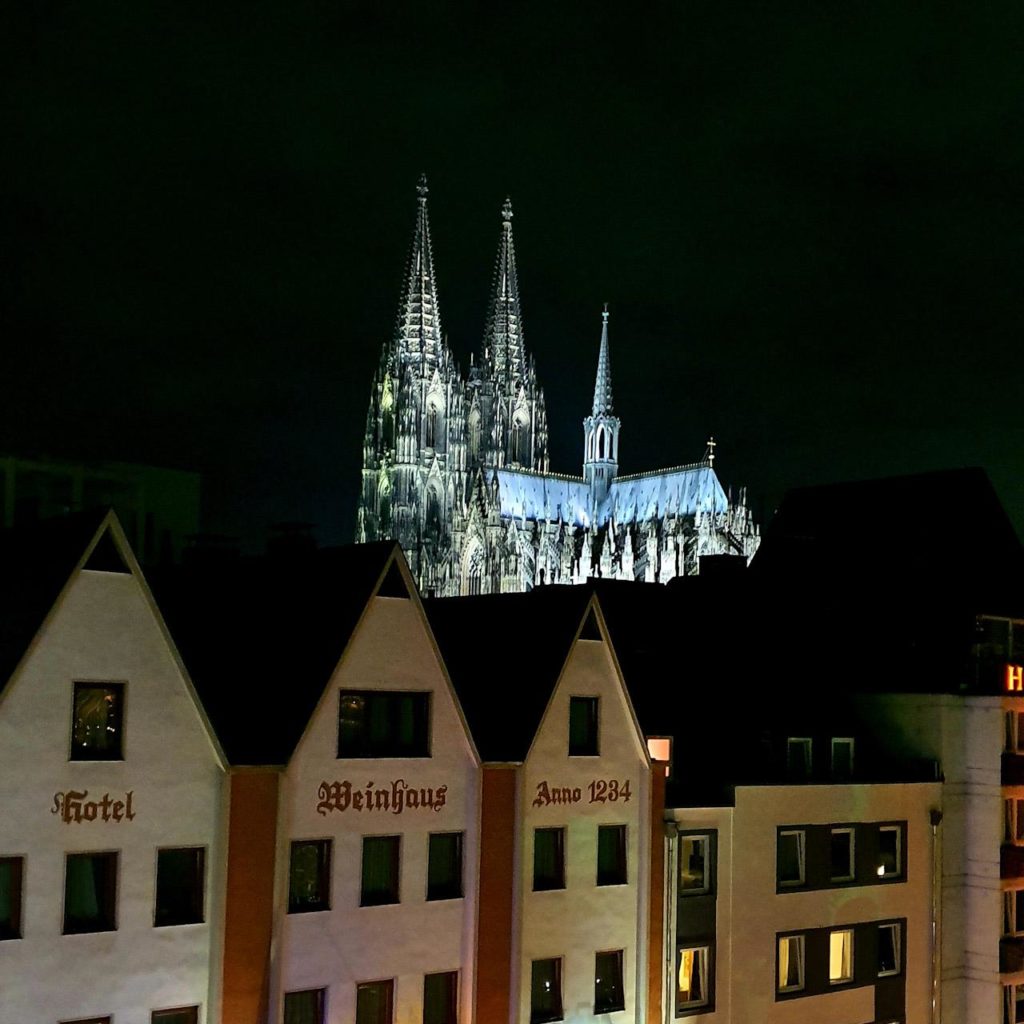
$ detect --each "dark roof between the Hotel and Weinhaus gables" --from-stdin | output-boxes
[150,542,396,765]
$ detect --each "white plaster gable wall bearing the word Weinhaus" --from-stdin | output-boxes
[272,598,485,1024]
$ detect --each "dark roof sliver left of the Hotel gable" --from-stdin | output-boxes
[0,509,108,693]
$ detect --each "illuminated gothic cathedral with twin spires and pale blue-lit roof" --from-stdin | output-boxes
[356,178,760,597]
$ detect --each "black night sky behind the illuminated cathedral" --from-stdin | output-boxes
[0,0,1024,554]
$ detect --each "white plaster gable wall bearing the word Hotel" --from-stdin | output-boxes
[0,571,224,1024]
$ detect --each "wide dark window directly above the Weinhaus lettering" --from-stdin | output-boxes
[338,690,430,758]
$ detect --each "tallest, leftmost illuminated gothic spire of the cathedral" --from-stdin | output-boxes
[392,174,443,376]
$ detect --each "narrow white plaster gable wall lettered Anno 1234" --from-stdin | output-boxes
[513,640,650,1024]
